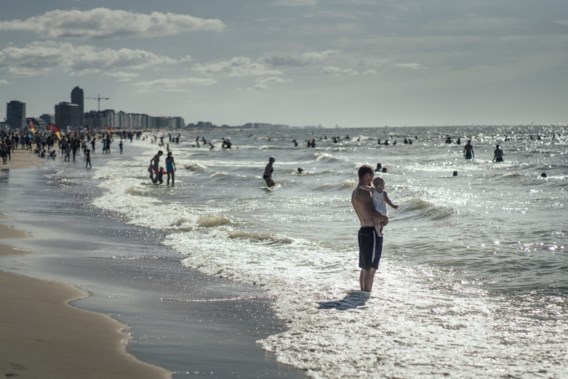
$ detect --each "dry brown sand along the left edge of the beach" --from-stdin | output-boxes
[0,150,170,379]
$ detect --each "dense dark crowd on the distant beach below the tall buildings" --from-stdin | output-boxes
[0,129,142,168]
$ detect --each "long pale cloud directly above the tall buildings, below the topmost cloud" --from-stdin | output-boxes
[0,41,181,77]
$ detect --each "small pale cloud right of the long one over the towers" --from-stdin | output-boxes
[192,57,282,77]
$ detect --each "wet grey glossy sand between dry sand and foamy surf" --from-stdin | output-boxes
[0,143,305,379]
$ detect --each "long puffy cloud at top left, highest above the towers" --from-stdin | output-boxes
[0,8,225,38]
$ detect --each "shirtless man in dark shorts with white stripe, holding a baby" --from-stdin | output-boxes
[351,165,389,292]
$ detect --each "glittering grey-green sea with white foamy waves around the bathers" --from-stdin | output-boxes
[1,125,568,378]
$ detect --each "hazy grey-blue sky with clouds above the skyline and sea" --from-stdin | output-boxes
[0,0,568,127]
